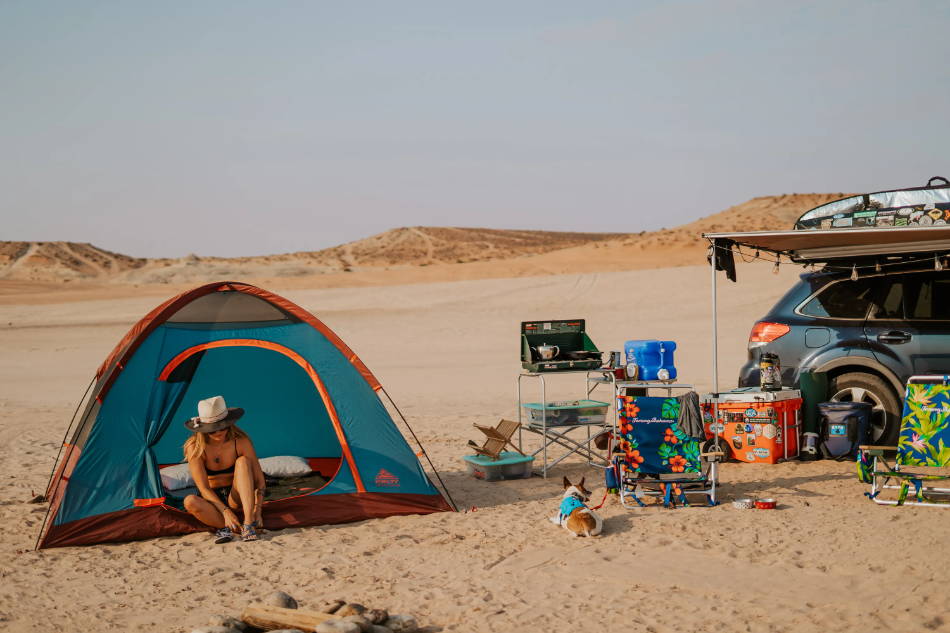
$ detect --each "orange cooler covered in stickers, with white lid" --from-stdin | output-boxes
[702,387,802,464]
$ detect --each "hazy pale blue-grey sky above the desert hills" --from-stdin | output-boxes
[0,0,950,257]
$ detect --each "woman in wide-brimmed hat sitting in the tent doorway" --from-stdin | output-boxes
[184,396,264,543]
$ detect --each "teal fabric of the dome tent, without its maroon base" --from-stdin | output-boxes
[40,282,449,544]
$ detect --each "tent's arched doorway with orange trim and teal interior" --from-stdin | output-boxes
[152,339,352,500]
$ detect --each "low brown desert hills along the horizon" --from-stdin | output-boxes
[0,193,846,284]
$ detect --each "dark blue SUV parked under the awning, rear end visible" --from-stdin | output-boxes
[739,263,950,445]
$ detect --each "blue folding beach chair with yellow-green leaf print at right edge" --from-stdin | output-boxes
[858,376,950,507]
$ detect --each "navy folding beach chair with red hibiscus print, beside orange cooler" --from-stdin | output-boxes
[614,396,723,508]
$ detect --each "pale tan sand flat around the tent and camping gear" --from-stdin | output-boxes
[0,265,950,633]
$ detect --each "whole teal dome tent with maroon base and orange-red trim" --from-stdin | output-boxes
[37,282,452,548]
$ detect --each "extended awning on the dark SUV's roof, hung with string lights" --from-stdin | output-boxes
[703,225,950,262]
